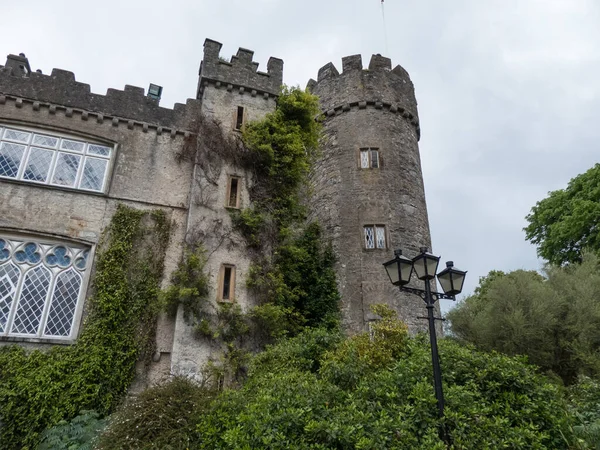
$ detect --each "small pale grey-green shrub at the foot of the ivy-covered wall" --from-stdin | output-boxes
[38,411,106,450]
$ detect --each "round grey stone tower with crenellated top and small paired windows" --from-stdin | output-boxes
[308,55,431,332]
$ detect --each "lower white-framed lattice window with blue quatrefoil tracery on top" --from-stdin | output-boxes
[0,233,90,339]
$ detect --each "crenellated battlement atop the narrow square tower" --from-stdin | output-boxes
[197,39,283,98]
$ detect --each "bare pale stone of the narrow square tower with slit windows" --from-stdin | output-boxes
[172,39,283,376]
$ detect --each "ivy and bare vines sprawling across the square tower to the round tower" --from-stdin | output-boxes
[165,87,339,382]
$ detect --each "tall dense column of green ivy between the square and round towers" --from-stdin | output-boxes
[233,87,339,336]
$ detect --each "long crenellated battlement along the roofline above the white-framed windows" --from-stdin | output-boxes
[0,55,198,129]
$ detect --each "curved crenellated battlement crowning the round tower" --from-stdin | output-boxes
[307,55,420,134]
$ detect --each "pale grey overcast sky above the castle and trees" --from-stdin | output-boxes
[0,0,600,309]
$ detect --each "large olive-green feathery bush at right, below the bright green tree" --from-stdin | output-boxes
[448,254,600,384]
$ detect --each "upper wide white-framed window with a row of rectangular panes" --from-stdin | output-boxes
[0,124,113,192]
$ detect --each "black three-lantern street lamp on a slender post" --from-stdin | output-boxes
[383,247,467,442]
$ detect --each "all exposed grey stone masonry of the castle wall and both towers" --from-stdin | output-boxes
[0,39,430,381]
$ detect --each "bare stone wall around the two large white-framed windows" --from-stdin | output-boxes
[0,72,199,381]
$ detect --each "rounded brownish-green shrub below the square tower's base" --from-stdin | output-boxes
[97,377,214,450]
